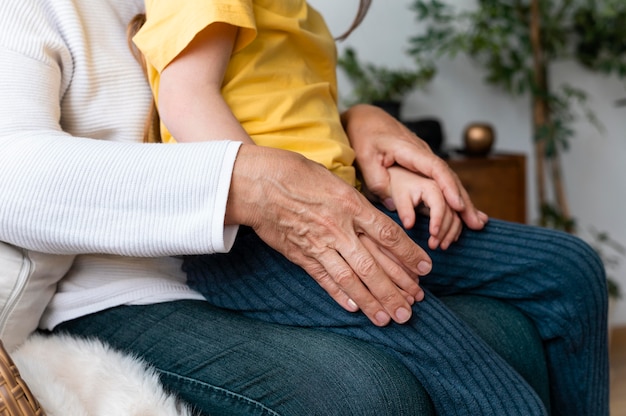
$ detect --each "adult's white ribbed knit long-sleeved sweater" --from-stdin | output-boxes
[0,0,239,334]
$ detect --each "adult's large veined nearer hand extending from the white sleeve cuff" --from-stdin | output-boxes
[226,145,432,326]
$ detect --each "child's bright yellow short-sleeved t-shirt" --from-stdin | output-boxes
[133,0,355,185]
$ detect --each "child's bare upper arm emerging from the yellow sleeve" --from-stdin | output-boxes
[157,23,253,143]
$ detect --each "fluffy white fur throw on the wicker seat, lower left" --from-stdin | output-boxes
[11,335,192,416]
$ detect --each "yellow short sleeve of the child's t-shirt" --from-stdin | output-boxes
[133,0,257,72]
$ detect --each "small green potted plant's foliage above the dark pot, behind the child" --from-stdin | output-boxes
[338,47,434,119]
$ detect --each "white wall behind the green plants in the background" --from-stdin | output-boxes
[310,0,626,325]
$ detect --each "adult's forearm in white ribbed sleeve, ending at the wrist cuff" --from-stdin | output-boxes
[0,132,238,256]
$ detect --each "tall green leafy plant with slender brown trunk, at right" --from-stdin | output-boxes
[409,0,626,299]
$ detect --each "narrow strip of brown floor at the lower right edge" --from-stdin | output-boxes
[611,326,626,416]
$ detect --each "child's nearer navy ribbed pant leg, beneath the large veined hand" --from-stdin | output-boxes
[184,228,545,415]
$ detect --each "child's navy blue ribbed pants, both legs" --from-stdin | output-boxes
[183,208,608,416]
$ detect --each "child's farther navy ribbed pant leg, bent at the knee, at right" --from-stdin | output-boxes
[410,216,609,415]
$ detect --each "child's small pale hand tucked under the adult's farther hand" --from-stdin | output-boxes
[386,166,463,250]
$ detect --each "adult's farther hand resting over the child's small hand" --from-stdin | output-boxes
[342,105,488,230]
